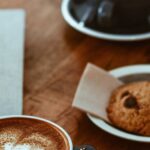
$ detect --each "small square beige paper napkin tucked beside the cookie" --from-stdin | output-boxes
[73,64,123,122]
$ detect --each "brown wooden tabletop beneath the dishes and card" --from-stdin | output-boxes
[0,0,150,150]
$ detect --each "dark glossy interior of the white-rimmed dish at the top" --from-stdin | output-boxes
[69,0,150,34]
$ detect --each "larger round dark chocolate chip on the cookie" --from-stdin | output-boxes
[124,95,138,108]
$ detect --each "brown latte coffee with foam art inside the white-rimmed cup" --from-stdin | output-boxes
[0,118,70,150]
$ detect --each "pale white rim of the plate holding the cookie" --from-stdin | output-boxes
[87,64,150,143]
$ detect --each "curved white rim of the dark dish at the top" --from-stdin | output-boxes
[61,0,150,41]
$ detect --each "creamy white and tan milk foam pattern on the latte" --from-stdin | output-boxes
[0,128,53,150]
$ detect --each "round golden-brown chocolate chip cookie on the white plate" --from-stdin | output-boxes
[107,81,150,136]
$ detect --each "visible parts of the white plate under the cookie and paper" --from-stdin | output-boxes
[87,65,150,143]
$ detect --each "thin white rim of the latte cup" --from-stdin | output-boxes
[0,115,73,150]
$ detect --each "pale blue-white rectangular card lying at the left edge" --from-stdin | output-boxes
[0,9,25,116]
